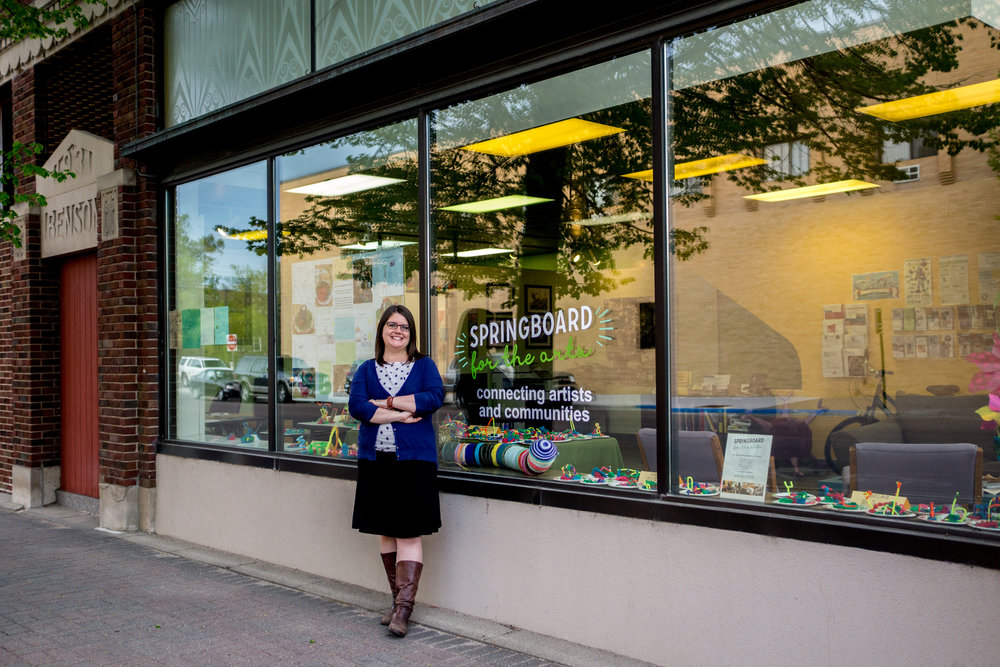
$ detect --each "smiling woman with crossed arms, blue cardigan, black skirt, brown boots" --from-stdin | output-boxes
[348,305,444,637]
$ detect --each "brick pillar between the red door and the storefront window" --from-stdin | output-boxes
[97,3,160,531]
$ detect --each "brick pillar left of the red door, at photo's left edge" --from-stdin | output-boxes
[0,70,60,507]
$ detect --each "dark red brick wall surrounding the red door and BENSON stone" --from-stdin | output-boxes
[0,3,159,493]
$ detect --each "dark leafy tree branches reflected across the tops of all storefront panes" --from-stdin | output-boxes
[221,10,1000,297]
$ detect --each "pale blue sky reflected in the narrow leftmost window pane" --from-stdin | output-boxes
[177,162,267,282]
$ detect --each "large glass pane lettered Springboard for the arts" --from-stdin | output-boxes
[431,53,655,488]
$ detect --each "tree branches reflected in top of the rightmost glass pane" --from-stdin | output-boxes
[673,9,1000,198]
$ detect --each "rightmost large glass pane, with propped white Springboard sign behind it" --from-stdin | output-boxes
[661,0,1000,523]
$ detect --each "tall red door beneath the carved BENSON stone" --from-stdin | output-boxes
[59,254,98,498]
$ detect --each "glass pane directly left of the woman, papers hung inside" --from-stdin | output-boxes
[276,120,420,457]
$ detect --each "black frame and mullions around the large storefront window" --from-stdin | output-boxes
[143,0,1000,569]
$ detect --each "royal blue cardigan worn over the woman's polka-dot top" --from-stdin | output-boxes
[347,357,444,463]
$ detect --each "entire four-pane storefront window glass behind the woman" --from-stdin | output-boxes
[167,0,1000,529]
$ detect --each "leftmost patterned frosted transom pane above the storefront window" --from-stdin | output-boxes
[163,0,312,127]
